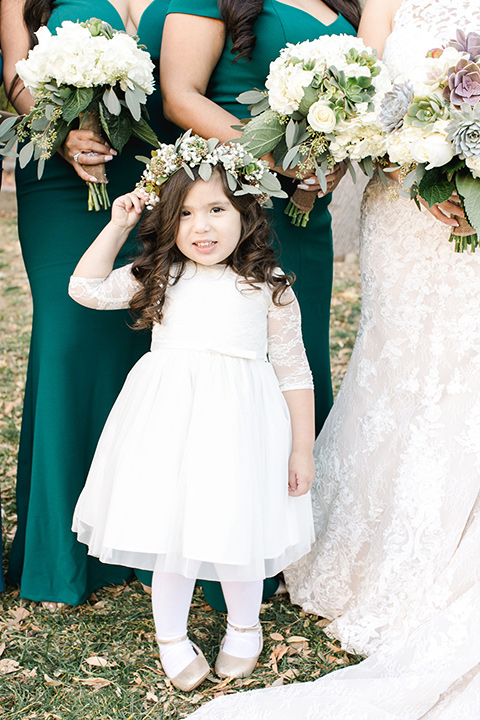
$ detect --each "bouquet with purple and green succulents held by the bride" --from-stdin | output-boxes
[380,31,480,252]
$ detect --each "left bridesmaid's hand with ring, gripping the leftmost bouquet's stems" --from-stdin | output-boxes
[58,130,117,182]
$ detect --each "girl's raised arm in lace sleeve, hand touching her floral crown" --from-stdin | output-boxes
[68,190,144,310]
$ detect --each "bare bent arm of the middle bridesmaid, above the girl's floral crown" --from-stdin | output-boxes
[160,13,241,142]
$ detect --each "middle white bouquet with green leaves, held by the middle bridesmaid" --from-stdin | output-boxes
[237,35,390,227]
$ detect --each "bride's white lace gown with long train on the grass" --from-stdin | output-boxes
[192,0,480,720]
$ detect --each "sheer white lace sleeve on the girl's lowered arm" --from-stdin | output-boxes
[268,288,313,391]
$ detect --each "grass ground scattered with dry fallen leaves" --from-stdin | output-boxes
[0,194,360,720]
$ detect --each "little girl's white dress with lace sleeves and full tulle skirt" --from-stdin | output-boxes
[69,262,313,581]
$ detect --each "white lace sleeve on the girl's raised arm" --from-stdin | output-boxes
[68,263,140,310]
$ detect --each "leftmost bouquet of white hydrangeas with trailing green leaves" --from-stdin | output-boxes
[0,18,158,210]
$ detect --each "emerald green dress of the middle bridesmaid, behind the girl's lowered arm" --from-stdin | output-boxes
[169,0,355,609]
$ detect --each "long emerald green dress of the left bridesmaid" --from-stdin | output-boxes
[8,0,178,605]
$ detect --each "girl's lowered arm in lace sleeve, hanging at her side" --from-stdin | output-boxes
[268,289,315,496]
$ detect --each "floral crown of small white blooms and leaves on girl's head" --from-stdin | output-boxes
[137,130,287,209]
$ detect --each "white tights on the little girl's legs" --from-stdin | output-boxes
[152,571,263,677]
